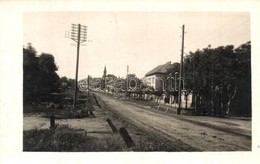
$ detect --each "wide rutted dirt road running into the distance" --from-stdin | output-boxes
[95,93,251,151]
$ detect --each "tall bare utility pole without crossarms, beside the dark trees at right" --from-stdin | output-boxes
[177,25,185,114]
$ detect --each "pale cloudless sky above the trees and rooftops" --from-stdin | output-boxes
[23,12,251,79]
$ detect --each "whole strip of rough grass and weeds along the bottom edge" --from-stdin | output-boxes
[23,125,179,152]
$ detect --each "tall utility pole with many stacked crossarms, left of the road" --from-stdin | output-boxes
[71,24,87,107]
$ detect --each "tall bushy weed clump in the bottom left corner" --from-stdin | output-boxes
[24,125,90,151]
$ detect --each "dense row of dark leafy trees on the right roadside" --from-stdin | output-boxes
[184,42,251,117]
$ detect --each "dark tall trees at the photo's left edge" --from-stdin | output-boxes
[23,43,59,103]
